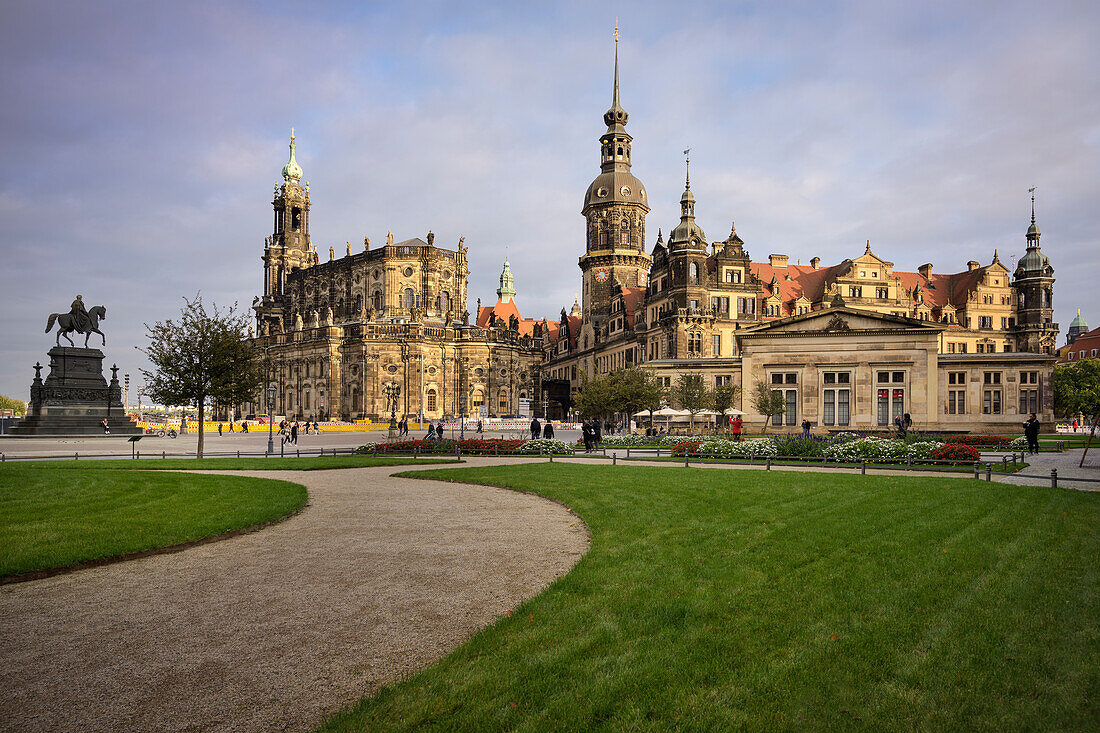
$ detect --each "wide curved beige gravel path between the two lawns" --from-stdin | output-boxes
[0,459,589,731]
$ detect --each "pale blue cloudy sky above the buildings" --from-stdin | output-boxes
[0,0,1100,400]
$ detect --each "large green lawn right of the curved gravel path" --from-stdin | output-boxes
[322,463,1100,731]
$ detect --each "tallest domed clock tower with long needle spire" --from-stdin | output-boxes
[579,28,650,320]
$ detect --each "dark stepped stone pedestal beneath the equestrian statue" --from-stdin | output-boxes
[11,347,141,437]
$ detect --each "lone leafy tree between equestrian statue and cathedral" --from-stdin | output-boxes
[141,295,264,458]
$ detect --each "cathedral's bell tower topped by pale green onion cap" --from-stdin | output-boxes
[263,130,317,296]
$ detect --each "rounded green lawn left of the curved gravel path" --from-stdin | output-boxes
[0,461,306,577]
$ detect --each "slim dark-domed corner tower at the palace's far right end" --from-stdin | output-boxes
[1012,188,1058,353]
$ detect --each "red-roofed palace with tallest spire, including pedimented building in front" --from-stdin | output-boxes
[542,41,1058,429]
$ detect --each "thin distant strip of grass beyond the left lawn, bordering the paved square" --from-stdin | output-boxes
[29,455,462,471]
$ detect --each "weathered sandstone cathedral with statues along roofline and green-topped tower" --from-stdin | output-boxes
[244,134,542,422]
